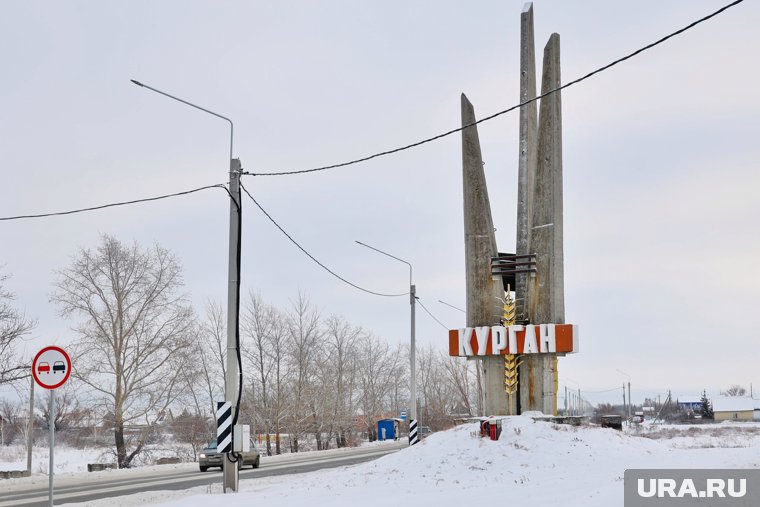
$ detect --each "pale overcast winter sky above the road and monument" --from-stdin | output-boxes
[0,0,760,401]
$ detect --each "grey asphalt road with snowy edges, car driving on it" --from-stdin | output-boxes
[0,442,406,507]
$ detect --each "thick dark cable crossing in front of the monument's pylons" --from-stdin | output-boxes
[243,0,744,176]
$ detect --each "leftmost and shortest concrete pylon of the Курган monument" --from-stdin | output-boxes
[462,94,507,415]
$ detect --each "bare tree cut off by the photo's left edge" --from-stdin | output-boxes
[0,274,37,385]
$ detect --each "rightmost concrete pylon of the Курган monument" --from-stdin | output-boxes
[519,33,565,414]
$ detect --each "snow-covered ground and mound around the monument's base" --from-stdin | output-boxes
[5,416,760,507]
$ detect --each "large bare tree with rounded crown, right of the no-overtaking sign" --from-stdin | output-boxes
[51,235,194,467]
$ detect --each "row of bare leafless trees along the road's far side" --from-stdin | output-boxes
[0,235,478,467]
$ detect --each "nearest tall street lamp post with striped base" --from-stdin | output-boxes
[131,79,243,493]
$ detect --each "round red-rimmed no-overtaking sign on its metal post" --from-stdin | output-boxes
[32,346,71,507]
